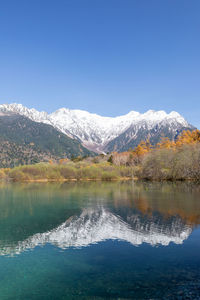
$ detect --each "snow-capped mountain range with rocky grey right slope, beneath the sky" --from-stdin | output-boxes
[0,103,194,152]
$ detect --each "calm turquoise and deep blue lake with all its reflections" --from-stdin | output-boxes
[0,182,200,300]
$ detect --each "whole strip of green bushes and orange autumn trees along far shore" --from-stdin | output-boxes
[0,130,200,182]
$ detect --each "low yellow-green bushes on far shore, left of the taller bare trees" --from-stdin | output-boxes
[0,161,134,181]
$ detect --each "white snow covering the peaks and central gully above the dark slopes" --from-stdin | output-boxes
[0,103,190,152]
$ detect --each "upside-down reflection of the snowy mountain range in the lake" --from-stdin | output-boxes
[0,206,192,255]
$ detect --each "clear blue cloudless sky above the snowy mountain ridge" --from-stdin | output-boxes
[0,0,200,127]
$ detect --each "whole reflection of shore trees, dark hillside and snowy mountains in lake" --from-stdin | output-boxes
[0,183,200,255]
